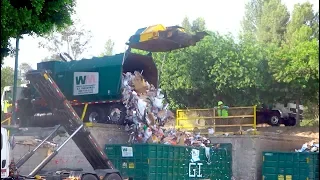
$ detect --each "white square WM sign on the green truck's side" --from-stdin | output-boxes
[73,72,99,96]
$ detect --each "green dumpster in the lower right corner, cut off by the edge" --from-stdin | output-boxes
[262,151,319,180]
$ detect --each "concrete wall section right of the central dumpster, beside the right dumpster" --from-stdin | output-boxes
[210,135,316,180]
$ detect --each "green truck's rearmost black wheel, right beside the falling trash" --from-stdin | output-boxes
[106,103,126,125]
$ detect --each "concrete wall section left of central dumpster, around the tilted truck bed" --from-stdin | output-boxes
[12,125,129,175]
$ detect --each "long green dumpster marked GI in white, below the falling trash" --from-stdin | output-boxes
[105,144,232,180]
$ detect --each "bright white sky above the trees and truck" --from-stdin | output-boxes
[4,0,319,69]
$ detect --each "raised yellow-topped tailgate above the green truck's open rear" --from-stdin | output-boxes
[127,24,208,52]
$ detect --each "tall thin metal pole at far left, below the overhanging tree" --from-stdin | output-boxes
[12,36,20,125]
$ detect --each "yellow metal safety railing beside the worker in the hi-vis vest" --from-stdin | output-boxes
[175,106,257,134]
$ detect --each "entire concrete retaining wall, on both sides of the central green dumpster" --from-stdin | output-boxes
[13,125,311,180]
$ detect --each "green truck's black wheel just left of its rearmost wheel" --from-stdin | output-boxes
[84,105,106,123]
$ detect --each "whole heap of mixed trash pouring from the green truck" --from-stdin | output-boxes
[122,71,210,147]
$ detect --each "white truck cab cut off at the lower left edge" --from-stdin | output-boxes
[1,127,10,179]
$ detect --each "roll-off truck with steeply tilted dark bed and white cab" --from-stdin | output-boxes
[1,70,124,180]
